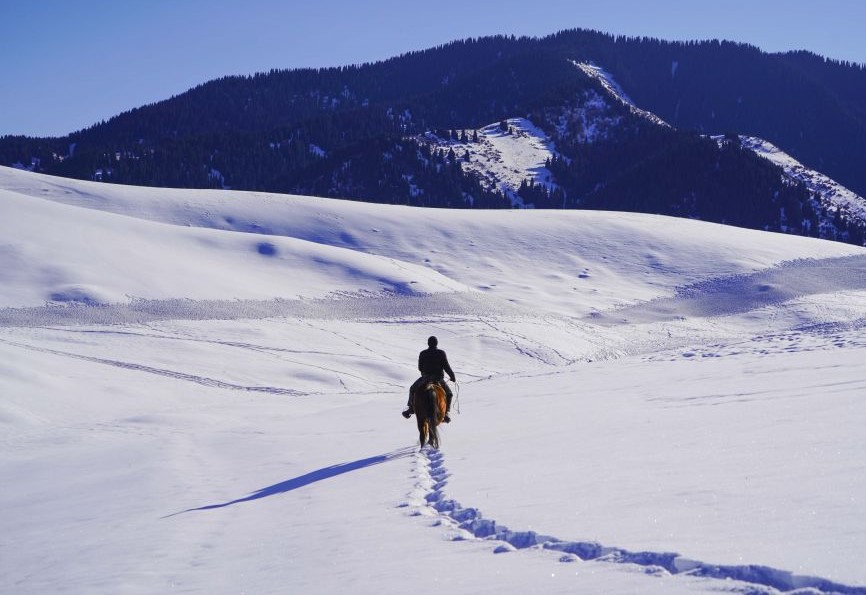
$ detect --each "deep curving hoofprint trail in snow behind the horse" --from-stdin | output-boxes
[408,446,866,595]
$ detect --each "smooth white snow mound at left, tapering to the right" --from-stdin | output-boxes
[0,184,463,306]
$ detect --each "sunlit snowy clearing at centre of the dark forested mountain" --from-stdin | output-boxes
[422,118,557,207]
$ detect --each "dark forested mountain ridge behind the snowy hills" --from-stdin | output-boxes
[0,30,866,243]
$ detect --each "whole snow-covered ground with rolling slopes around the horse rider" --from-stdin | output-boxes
[0,168,866,594]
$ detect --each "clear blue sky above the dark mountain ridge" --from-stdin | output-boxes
[0,0,866,136]
